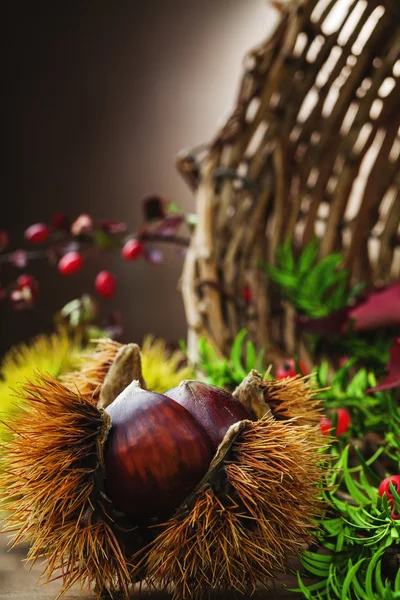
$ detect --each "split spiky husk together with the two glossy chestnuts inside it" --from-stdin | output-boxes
[0,340,326,600]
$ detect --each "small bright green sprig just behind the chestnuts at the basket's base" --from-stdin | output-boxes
[196,329,265,389]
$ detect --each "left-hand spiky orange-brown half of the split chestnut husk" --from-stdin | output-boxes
[0,375,144,595]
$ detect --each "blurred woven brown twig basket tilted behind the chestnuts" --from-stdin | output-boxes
[178,0,400,366]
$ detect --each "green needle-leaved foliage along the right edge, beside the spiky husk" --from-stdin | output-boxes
[292,356,400,600]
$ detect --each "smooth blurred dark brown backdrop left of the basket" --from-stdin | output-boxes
[0,0,274,354]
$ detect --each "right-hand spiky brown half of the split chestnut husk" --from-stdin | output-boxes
[146,415,325,598]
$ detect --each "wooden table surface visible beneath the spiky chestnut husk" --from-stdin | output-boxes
[0,534,300,600]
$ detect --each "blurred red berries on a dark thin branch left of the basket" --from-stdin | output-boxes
[0,196,189,310]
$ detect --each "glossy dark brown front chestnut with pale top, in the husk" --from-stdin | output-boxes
[105,382,214,519]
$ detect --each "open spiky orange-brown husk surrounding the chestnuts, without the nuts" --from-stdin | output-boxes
[0,341,326,598]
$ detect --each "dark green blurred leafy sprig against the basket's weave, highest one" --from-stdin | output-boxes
[263,238,363,318]
